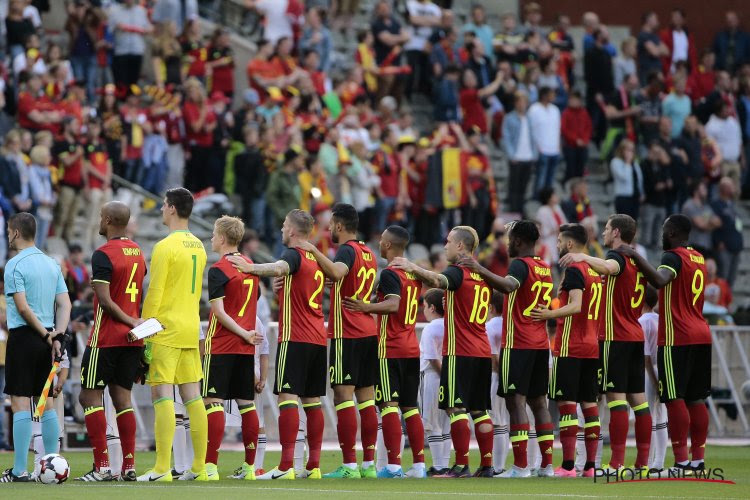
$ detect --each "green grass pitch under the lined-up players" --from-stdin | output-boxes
[0,446,750,500]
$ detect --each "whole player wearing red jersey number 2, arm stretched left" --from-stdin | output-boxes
[228,209,326,479]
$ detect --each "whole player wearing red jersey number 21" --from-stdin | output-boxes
[531,224,602,477]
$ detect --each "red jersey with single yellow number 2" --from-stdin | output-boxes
[279,248,326,345]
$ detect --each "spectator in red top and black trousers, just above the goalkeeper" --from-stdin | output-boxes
[182,78,216,192]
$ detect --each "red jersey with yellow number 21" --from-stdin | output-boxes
[552,262,602,358]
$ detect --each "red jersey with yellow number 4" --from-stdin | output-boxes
[88,237,146,347]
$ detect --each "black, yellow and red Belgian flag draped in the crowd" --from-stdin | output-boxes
[425,148,468,210]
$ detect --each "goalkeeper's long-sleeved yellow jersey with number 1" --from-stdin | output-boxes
[143,231,206,348]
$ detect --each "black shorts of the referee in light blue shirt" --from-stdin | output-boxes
[5,326,52,398]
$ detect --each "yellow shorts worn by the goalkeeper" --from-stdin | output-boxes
[146,344,203,385]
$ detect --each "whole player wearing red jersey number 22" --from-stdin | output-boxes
[302,203,378,478]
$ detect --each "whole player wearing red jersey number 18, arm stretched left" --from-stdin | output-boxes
[391,226,494,477]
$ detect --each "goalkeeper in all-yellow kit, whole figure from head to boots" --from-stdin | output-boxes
[138,188,208,481]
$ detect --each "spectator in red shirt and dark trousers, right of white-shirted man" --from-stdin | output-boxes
[560,90,592,184]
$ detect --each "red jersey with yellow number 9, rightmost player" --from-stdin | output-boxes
[659,247,711,346]
